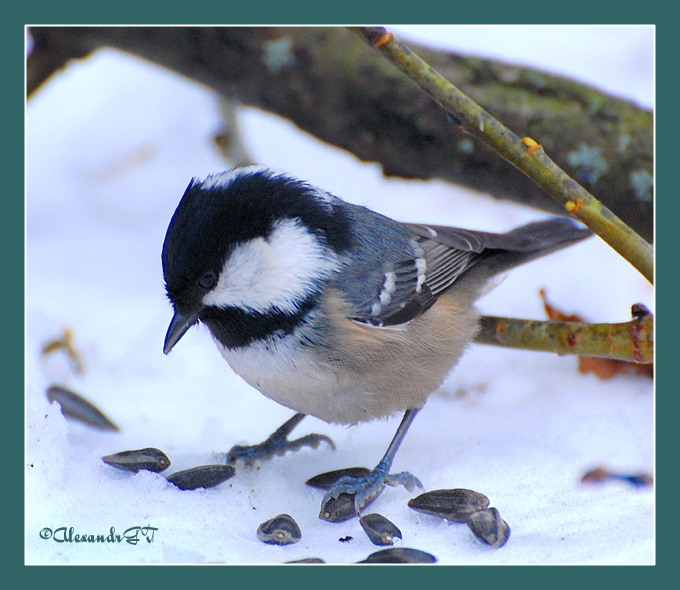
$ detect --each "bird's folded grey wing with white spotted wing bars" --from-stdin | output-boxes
[352,224,485,327]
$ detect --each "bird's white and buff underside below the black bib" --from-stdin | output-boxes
[210,289,478,424]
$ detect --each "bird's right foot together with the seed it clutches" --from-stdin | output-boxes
[319,462,423,522]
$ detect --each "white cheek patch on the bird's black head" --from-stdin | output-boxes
[203,219,336,314]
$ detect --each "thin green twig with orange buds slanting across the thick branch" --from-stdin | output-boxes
[353,27,654,283]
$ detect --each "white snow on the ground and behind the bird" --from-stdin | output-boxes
[25,26,655,565]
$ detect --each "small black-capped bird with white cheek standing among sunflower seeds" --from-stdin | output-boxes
[162,166,591,513]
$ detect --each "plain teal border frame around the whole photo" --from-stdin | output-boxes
[15,0,664,588]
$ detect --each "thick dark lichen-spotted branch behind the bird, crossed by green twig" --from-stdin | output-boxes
[27,27,653,240]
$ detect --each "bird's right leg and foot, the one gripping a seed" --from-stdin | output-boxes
[320,408,423,520]
